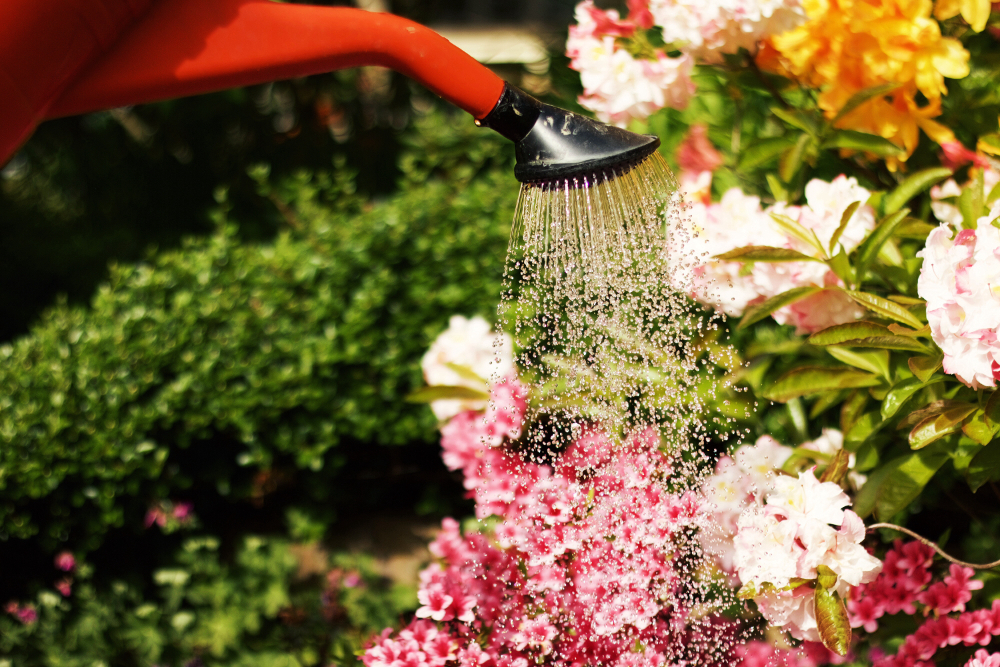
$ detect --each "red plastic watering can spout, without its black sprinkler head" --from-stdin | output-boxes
[0,0,504,164]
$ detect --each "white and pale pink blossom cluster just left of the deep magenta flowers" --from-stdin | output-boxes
[733,470,882,642]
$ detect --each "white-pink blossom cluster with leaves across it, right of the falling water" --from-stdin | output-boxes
[672,172,875,333]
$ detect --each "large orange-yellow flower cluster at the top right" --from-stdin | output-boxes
[758,0,969,168]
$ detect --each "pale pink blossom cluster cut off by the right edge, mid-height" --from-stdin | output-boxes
[917,206,1000,389]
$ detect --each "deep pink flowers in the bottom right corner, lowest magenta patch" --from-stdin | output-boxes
[874,600,1000,667]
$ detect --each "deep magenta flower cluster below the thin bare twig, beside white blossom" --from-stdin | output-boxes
[847,540,983,632]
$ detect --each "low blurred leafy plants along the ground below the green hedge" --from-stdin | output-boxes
[0,537,416,667]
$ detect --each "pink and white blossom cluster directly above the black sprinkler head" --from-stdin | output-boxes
[566,0,695,127]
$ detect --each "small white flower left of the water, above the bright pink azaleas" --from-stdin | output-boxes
[420,315,514,421]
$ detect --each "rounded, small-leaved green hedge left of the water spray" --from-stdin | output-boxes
[0,111,517,549]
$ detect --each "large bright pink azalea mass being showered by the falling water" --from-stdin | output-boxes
[363,380,732,667]
